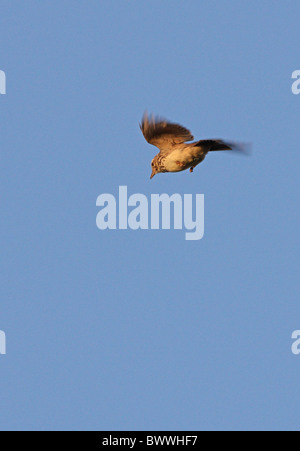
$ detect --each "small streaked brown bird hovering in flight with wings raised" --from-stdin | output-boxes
[140,112,248,179]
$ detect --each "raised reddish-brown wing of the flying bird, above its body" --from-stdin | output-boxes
[140,113,194,153]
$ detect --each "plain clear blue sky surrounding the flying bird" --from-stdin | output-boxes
[0,0,300,431]
